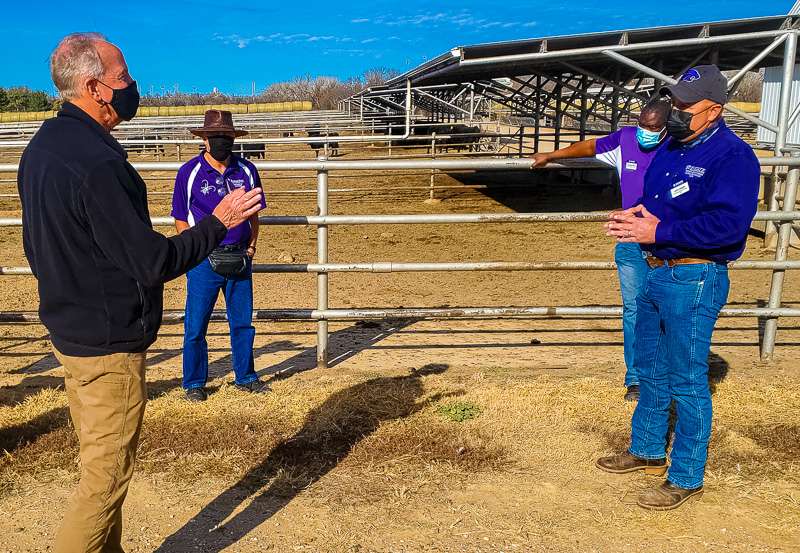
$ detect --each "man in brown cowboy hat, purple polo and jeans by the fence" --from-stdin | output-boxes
[172,109,267,401]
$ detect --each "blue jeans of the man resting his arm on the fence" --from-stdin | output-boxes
[614,243,650,386]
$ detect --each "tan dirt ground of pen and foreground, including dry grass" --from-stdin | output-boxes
[0,135,800,553]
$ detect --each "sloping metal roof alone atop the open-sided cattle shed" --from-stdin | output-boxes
[387,16,800,87]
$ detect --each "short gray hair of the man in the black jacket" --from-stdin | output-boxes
[50,33,107,100]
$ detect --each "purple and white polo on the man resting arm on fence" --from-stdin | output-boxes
[595,127,667,209]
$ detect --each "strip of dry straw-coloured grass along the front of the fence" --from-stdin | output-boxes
[0,362,800,492]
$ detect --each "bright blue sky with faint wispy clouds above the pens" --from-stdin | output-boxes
[0,0,793,94]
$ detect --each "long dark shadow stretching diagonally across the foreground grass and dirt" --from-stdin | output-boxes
[152,365,447,553]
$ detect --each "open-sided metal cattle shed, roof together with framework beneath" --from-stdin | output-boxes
[341,15,800,149]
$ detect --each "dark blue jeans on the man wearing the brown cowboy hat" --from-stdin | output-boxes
[183,259,258,390]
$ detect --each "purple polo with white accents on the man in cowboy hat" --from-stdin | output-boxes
[172,153,267,246]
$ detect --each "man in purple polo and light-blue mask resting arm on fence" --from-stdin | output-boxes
[533,98,671,401]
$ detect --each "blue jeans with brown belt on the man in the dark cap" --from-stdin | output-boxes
[630,263,730,488]
